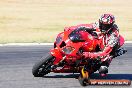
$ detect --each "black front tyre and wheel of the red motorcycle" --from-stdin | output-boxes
[32,54,54,77]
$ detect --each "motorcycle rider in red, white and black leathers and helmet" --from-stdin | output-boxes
[65,14,126,76]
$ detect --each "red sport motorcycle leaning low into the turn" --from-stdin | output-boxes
[32,29,126,86]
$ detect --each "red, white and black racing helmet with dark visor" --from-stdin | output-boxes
[99,14,115,33]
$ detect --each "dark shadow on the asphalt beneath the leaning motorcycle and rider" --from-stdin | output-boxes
[43,73,132,80]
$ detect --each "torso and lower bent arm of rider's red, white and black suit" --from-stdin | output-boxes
[83,23,123,65]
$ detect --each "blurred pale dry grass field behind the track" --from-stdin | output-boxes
[0,0,132,44]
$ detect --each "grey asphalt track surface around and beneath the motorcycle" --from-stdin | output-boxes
[0,44,132,88]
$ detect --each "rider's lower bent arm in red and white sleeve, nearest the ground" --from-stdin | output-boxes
[83,33,118,58]
